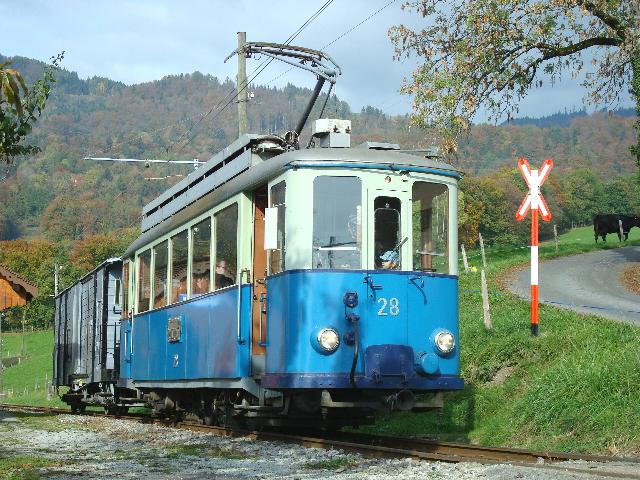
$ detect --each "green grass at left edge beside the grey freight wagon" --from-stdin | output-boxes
[2,330,65,407]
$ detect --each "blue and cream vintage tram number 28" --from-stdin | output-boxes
[112,119,463,426]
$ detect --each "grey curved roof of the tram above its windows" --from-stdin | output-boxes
[123,146,461,258]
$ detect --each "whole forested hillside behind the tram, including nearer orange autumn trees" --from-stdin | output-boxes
[0,56,640,326]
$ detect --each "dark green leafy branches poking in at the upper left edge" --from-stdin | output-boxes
[0,52,64,163]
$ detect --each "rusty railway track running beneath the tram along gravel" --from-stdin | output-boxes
[0,404,640,480]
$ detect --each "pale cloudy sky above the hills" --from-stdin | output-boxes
[0,0,631,121]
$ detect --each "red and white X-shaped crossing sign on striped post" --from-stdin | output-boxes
[516,158,553,336]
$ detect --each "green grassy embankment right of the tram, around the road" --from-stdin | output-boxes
[370,227,640,455]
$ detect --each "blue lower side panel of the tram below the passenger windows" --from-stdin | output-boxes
[128,285,251,382]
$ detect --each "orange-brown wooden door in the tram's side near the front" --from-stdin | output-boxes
[251,185,267,375]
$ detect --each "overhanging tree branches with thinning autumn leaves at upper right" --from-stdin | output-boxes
[389,0,640,166]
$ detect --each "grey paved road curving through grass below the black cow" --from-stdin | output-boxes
[509,247,640,325]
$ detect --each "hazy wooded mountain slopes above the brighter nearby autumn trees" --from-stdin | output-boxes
[0,56,636,241]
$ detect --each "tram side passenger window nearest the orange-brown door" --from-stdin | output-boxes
[214,203,238,290]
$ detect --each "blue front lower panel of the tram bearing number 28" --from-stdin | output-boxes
[262,270,463,391]
